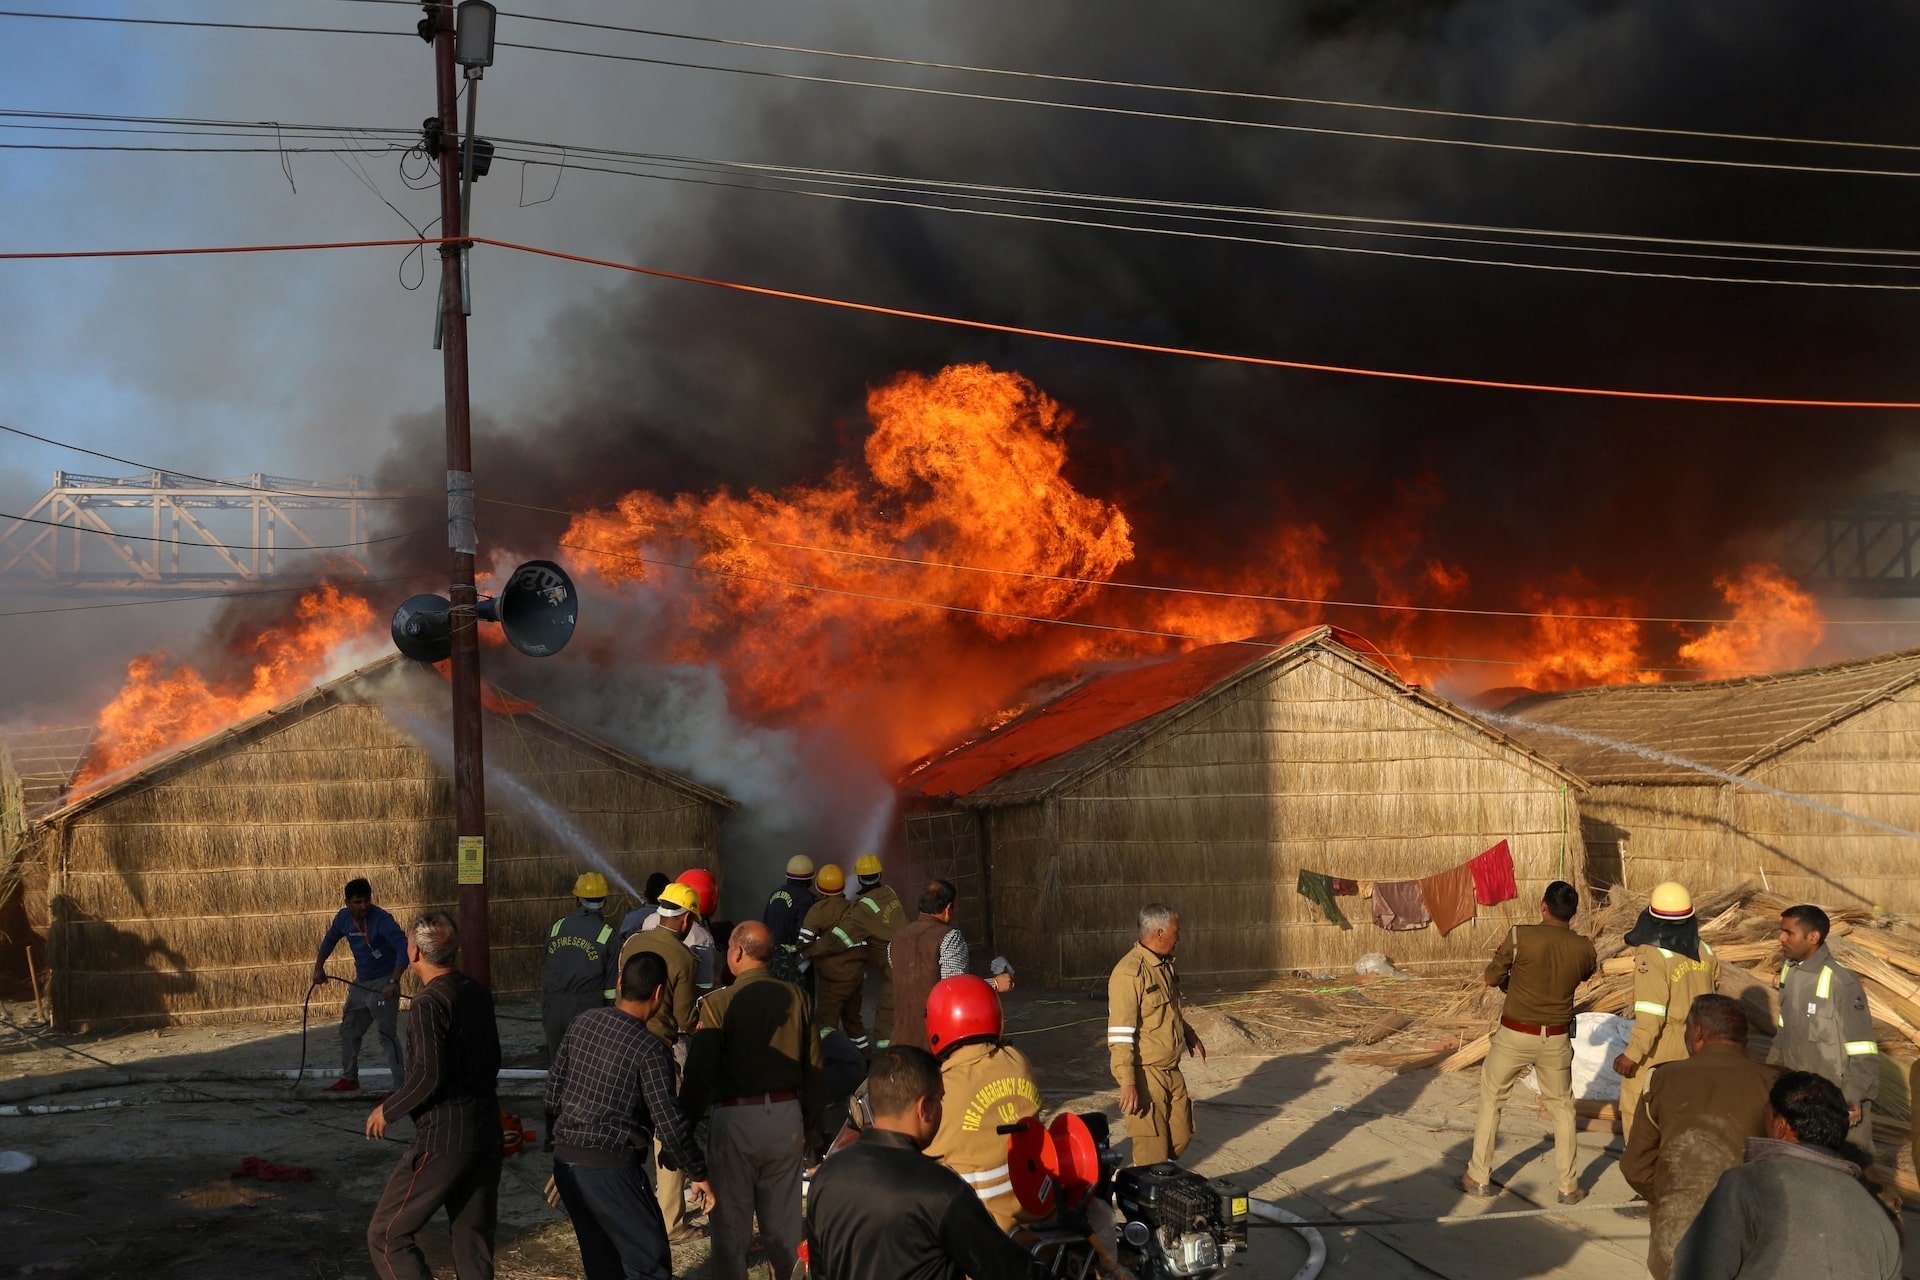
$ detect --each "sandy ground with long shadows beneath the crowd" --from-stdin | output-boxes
[11,990,1920,1280]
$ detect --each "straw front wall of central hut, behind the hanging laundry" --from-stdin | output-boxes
[975,654,1584,984]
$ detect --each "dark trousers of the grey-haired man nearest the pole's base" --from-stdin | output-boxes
[367,1146,501,1280]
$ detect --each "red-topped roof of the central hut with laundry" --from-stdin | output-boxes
[900,626,1578,808]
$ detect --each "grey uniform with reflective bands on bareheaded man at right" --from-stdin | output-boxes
[1766,942,1880,1163]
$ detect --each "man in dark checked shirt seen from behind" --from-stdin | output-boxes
[547,950,714,1280]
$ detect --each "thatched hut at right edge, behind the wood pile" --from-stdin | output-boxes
[1501,649,1920,912]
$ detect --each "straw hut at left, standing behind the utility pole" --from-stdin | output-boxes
[27,658,735,1027]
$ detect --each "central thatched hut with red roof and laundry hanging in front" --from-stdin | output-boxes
[902,628,1582,983]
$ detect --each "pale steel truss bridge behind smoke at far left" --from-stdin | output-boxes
[0,470,397,591]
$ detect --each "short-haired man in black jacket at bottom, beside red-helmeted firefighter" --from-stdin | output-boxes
[806,1046,1039,1280]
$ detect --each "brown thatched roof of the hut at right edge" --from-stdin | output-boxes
[1503,649,1920,785]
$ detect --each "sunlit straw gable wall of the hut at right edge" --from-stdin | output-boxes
[1582,693,1920,913]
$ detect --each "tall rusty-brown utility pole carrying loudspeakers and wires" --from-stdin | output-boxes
[430,0,493,986]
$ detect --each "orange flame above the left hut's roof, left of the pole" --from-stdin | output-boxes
[73,585,374,794]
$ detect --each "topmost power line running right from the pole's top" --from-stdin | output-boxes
[460,0,1920,152]
